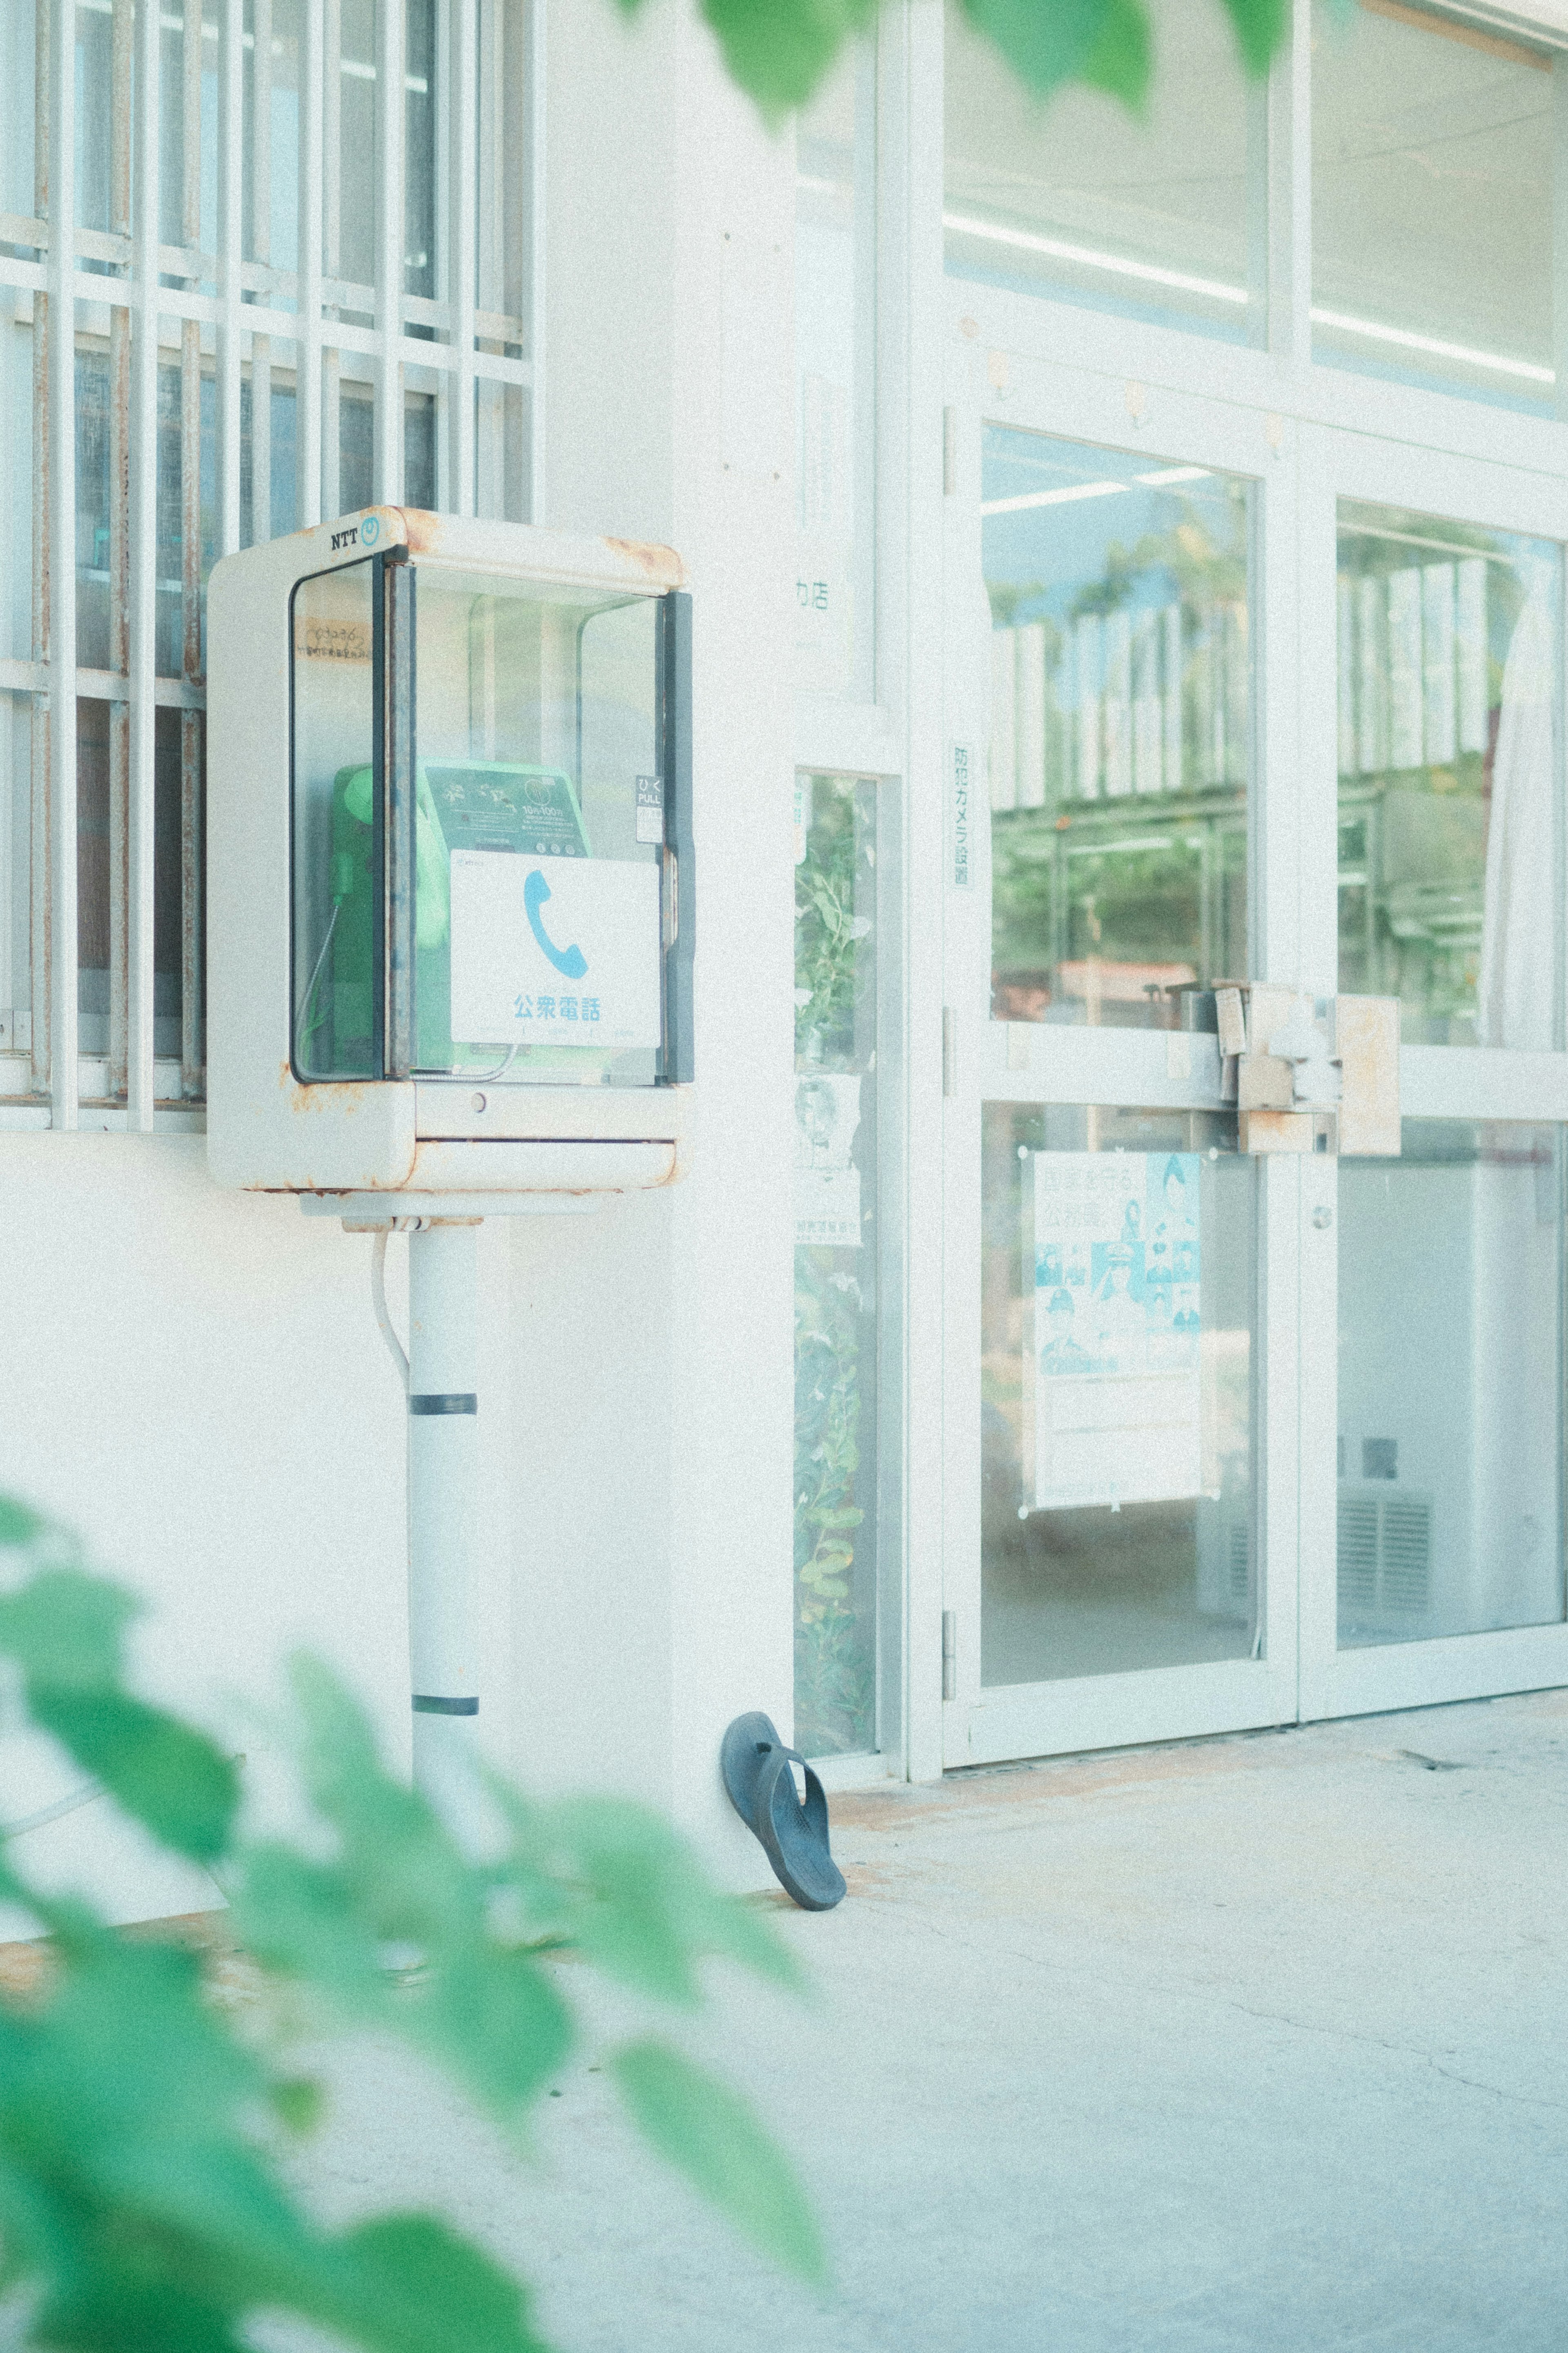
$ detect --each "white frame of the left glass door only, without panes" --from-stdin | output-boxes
[943,341,1302,1767]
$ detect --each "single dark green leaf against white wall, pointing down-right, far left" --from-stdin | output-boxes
[28,1678,240,1864]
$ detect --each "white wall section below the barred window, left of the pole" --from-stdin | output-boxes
[0,1134,421,1918]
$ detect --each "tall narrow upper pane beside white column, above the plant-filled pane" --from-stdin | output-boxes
[795,45,877,701]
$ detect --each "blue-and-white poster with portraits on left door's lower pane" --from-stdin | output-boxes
[1034,1153,1201,1511]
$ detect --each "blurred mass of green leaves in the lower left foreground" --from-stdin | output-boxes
[0,1499,825,2353]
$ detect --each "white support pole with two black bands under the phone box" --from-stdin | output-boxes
[409,1221,479,1807]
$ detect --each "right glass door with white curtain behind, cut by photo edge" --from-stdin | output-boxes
[1302,433,1568,1715]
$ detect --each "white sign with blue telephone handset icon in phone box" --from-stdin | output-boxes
[451,850,663,1054]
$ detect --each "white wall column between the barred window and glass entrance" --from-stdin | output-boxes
[526,0,795,1885]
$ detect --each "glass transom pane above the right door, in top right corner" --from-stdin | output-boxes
[1312,0,1563,412]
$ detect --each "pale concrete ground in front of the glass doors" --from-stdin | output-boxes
[12,1692,1568,2353]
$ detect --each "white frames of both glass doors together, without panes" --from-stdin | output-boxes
[943,339,1568,1767]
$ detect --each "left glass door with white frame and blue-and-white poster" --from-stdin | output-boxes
[943,355,1302,1765]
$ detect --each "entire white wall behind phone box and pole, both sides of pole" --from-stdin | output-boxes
[0,0,795,1934]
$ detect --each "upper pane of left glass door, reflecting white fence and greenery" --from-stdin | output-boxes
[980,426,1253,1028]
